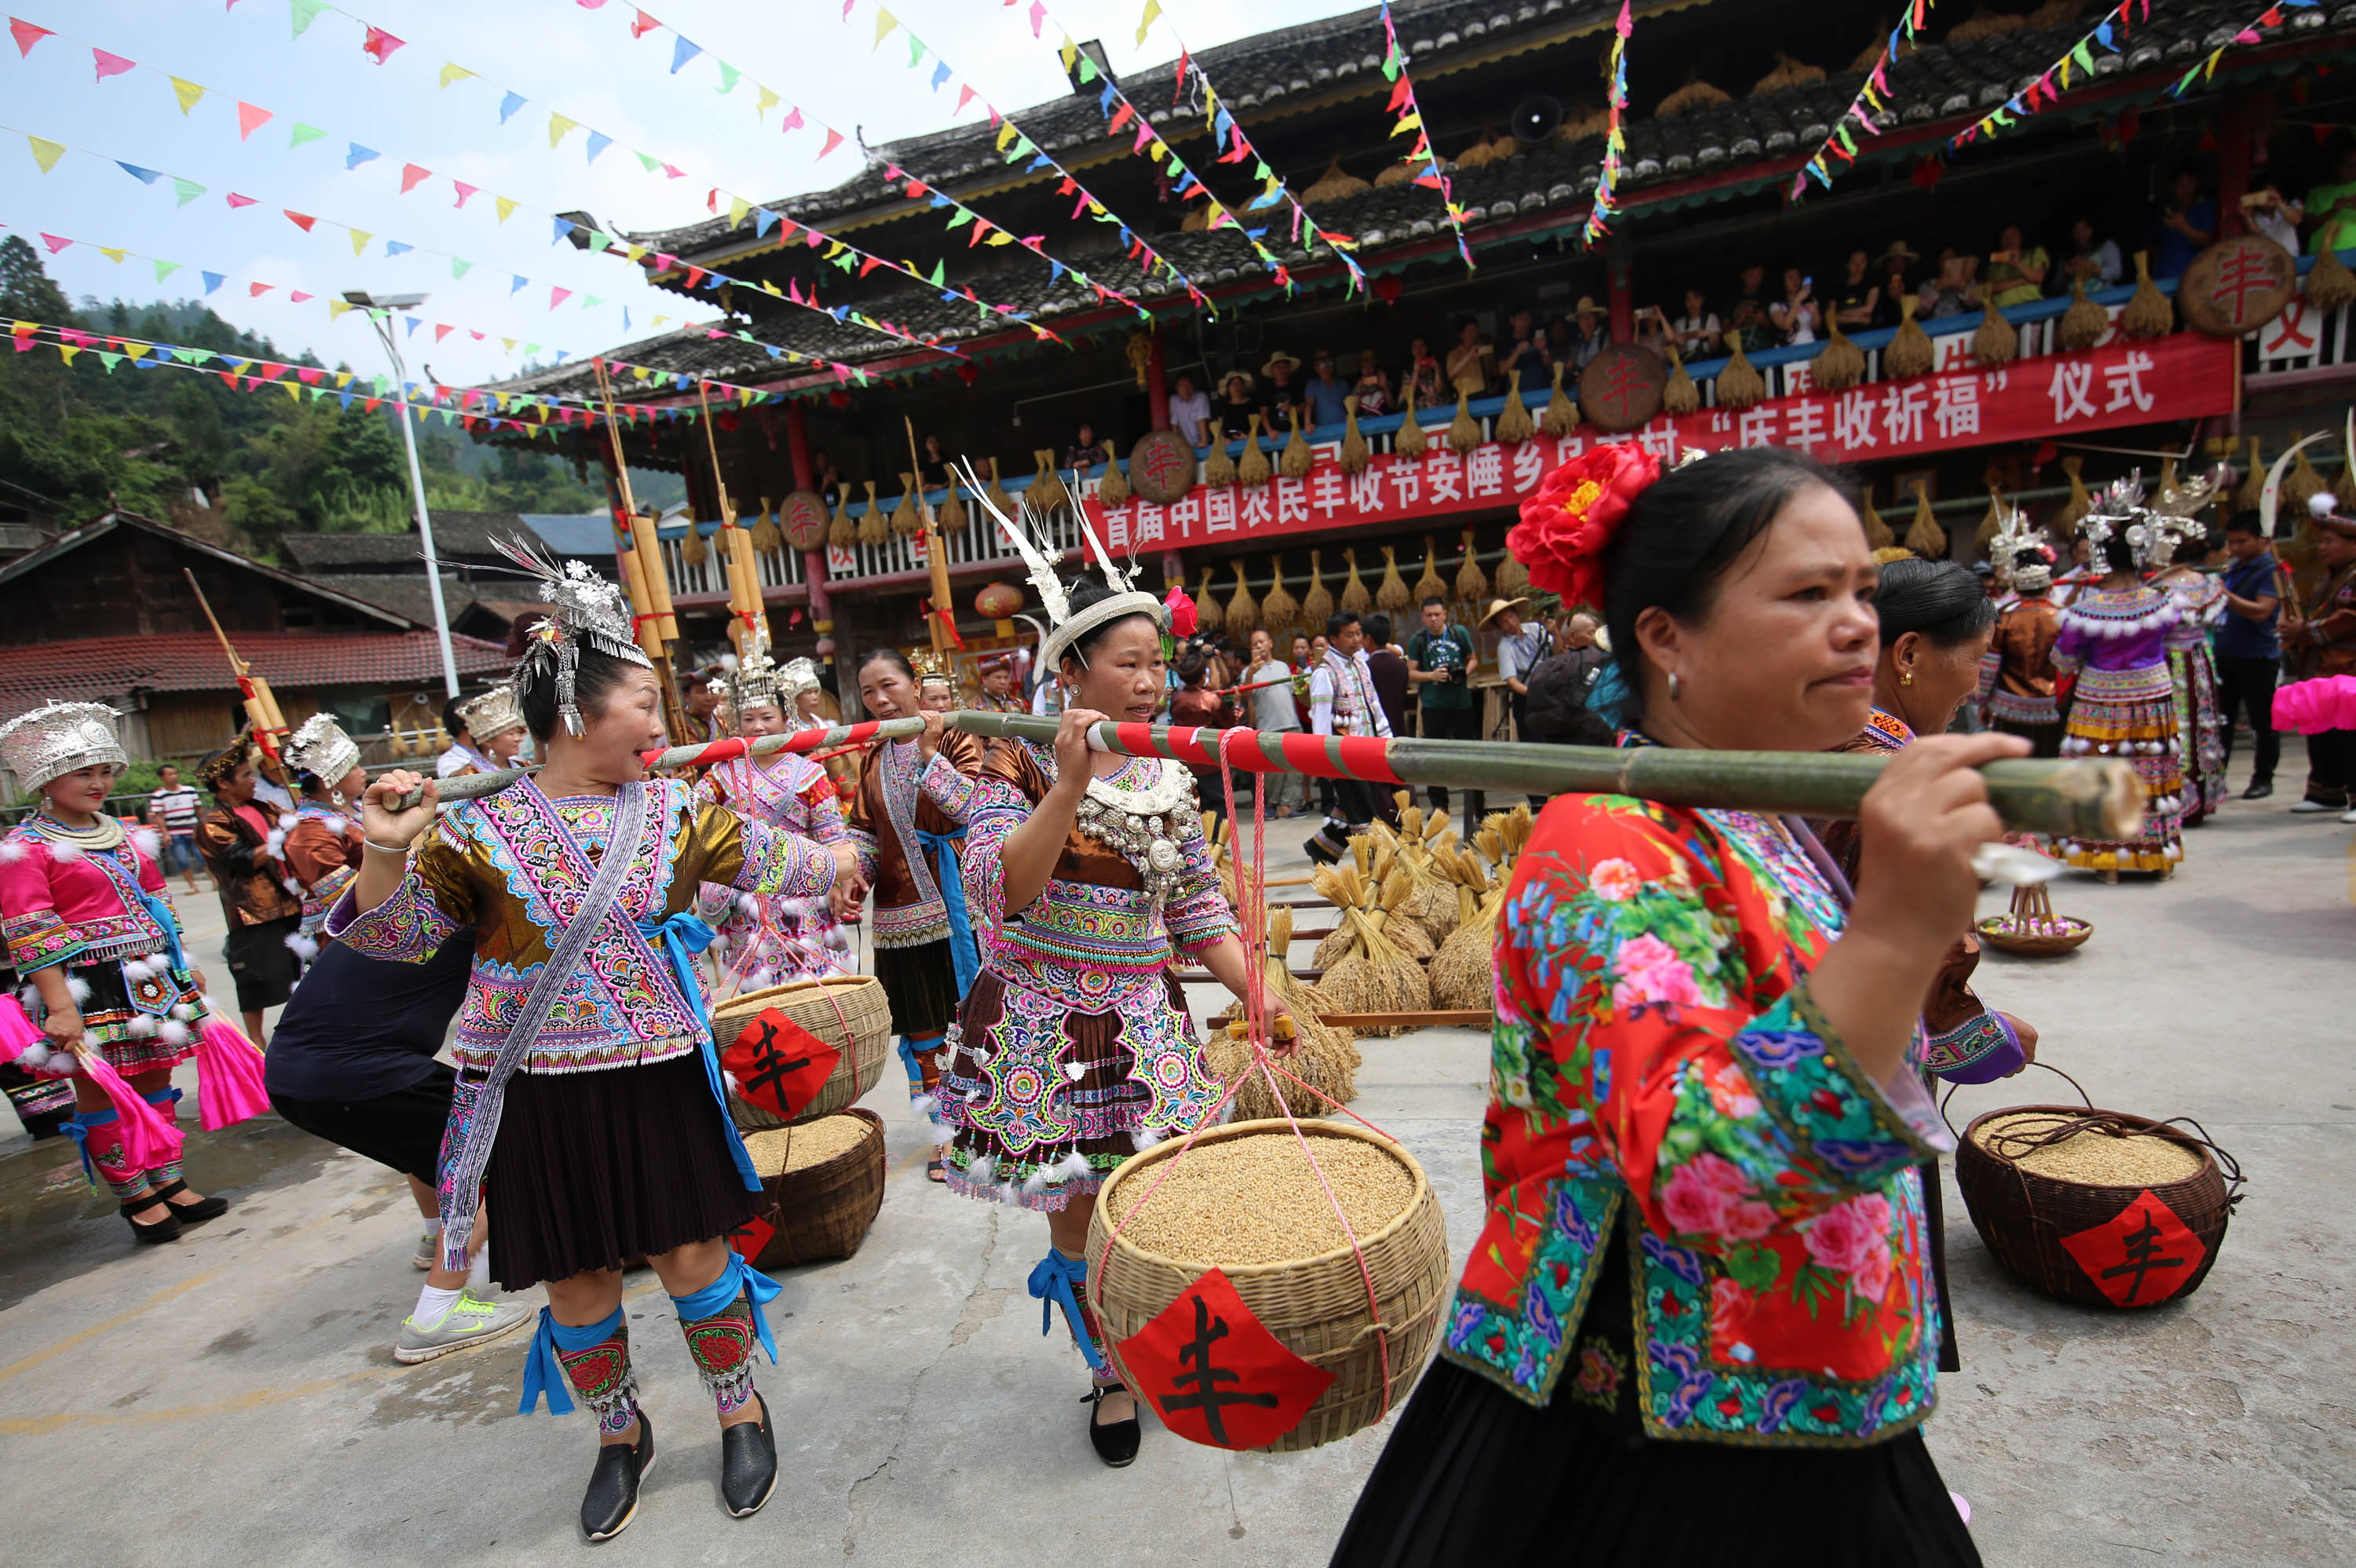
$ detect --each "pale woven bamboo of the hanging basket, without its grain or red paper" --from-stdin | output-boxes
[1088,1120,1454,1453]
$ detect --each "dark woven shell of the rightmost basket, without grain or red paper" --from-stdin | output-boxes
[1955,1062,2243,1311]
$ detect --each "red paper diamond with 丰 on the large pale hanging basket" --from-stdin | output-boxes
[1119,1269,1333,1448]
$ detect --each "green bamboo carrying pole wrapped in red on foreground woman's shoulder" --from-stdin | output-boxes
[947,714,2144,842]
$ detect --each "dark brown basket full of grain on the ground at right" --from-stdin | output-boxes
[1955,1069,2241,1311]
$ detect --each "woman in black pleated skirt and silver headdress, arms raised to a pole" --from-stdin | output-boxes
[327,539,855,1540]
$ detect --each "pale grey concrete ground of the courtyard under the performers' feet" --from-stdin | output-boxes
[0,766,2356,1568]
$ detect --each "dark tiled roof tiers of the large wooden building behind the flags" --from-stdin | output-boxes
[504,0,2356,393]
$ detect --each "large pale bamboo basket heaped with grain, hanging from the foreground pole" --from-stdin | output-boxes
[1088,1120,1451,1453]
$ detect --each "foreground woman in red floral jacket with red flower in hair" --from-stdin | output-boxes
[1333,445,2029,1568]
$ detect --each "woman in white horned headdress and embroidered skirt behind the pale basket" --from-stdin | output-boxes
[940,489,1282,1467]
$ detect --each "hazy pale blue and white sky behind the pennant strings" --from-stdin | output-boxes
[0,0,1374,384]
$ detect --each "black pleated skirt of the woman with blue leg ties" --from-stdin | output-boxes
[483,1052,761,1290]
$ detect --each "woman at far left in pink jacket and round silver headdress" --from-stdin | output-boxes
[0,702,229,1245]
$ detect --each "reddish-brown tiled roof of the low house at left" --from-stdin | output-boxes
[0,631,509,716]
